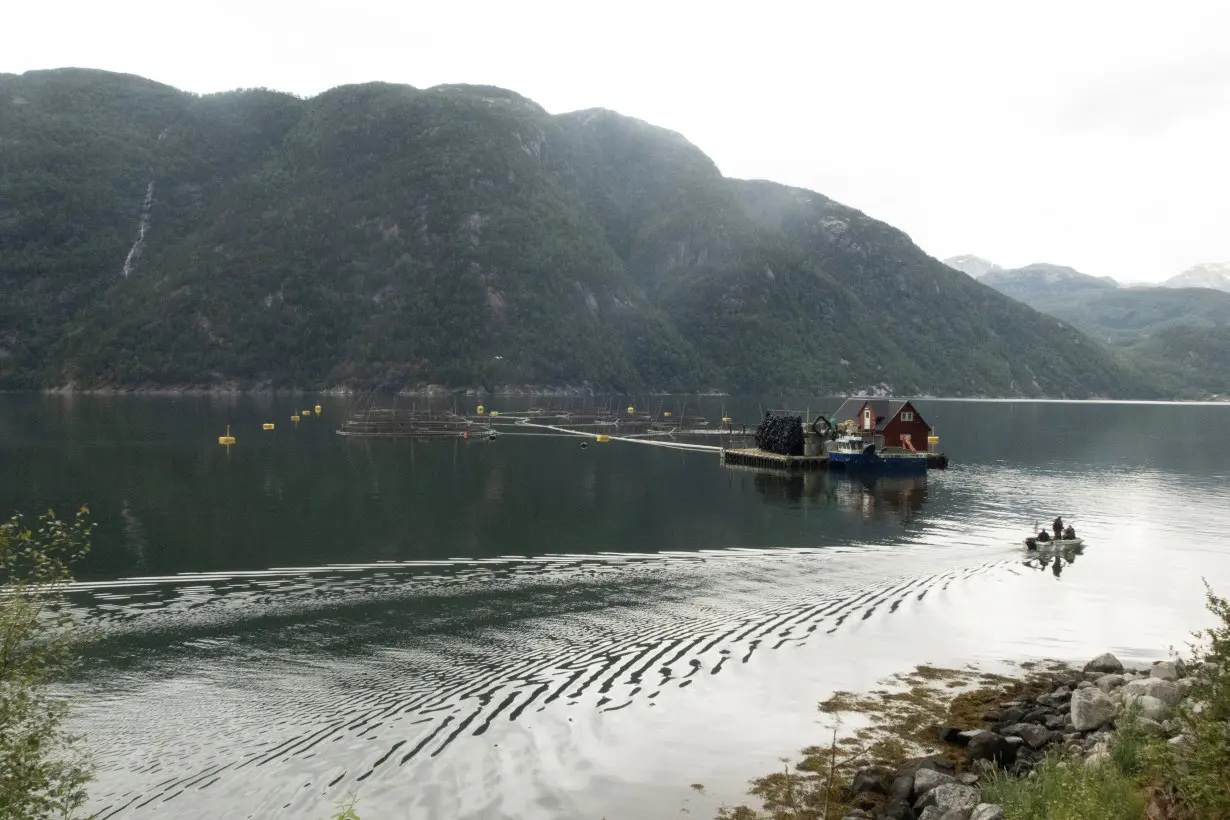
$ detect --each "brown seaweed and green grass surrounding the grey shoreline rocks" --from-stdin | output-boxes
[718,582,1230,820]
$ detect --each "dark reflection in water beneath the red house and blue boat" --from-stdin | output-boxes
[753,471,926,521]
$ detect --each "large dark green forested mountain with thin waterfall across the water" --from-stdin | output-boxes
[0,69,1157,396]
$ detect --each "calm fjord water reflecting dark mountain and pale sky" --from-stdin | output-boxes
[0,396,1230,820]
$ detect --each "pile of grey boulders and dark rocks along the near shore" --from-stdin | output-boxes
[841,653,1204,820]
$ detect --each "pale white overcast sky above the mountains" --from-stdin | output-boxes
[0,0,1230,280]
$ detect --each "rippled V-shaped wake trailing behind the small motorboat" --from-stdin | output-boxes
[76,550,1011,819]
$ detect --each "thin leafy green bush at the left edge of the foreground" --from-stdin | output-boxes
[0,508,92,820]
